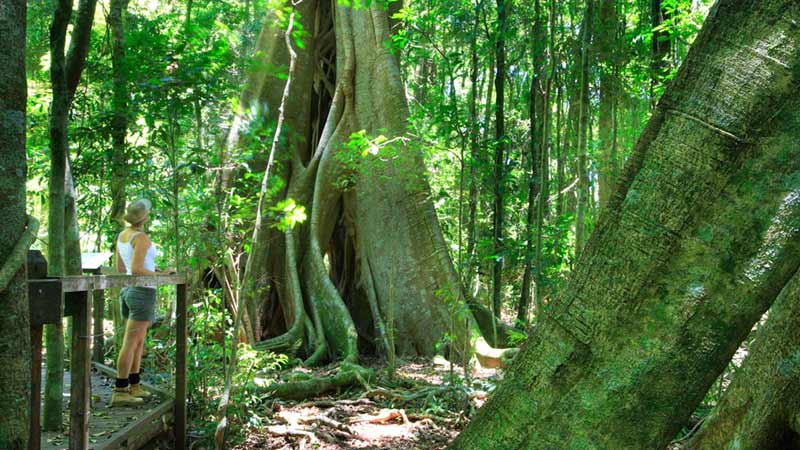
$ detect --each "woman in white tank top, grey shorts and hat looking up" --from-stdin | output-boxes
[111,199,174,406]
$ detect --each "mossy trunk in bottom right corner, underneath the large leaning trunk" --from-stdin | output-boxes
[688,260,800,450]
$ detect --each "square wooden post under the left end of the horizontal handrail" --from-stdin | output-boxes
[69,288,92,450]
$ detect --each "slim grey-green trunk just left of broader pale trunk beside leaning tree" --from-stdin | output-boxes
[575,0,595,255]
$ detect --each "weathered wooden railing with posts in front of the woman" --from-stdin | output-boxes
[28,275,187,450]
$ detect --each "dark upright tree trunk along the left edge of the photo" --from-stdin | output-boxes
[0,0,31,450]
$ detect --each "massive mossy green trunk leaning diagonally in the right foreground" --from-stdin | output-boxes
[451,0,800,450]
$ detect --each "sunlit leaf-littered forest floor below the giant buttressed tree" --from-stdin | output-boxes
[228,358,501,450]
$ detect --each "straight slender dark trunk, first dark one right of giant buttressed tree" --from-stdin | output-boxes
[492,0,506,317]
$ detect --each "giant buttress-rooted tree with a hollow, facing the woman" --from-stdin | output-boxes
[222,0,506,362]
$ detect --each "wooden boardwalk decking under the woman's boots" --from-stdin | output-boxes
[42,365,175,450]
